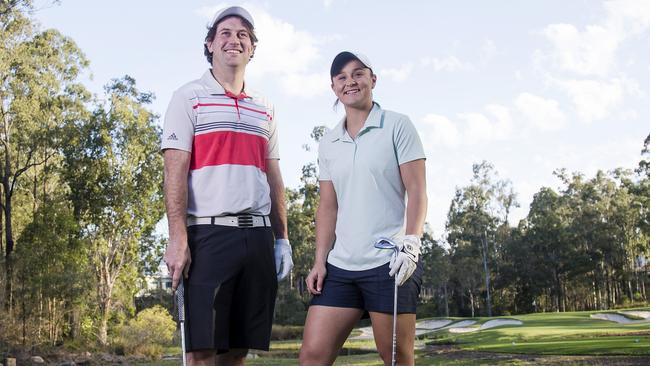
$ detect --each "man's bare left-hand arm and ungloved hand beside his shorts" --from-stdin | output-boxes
[164,149,192,289]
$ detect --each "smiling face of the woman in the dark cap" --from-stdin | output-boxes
[332,60,377,108]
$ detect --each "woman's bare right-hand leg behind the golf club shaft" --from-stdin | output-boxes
[370,312,415,366]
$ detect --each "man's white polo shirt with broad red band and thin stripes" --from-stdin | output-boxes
[161,70,280,217]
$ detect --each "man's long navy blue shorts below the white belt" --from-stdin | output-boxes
[184,225,278,353]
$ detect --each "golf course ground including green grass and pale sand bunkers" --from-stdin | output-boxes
[141,307,650,366]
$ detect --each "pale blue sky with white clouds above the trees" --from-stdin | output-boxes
[33,0,650,237]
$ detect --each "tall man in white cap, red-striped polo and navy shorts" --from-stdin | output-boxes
[162,6,293,365]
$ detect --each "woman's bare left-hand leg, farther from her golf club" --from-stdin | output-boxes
[300,305,363,366]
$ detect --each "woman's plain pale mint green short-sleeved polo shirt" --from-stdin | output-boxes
[318,103,425,271]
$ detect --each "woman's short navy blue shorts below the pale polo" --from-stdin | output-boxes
[310,263,423,317]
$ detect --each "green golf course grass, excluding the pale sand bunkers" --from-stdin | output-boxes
[135,307,650,366]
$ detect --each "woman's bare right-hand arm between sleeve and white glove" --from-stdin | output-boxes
[399,159,427,238]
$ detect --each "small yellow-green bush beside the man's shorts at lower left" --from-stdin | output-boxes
[115,305,176,359]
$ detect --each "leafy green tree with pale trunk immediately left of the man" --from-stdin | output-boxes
[63,76,163,345]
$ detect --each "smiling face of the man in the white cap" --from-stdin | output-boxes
[207,16,254,68]
